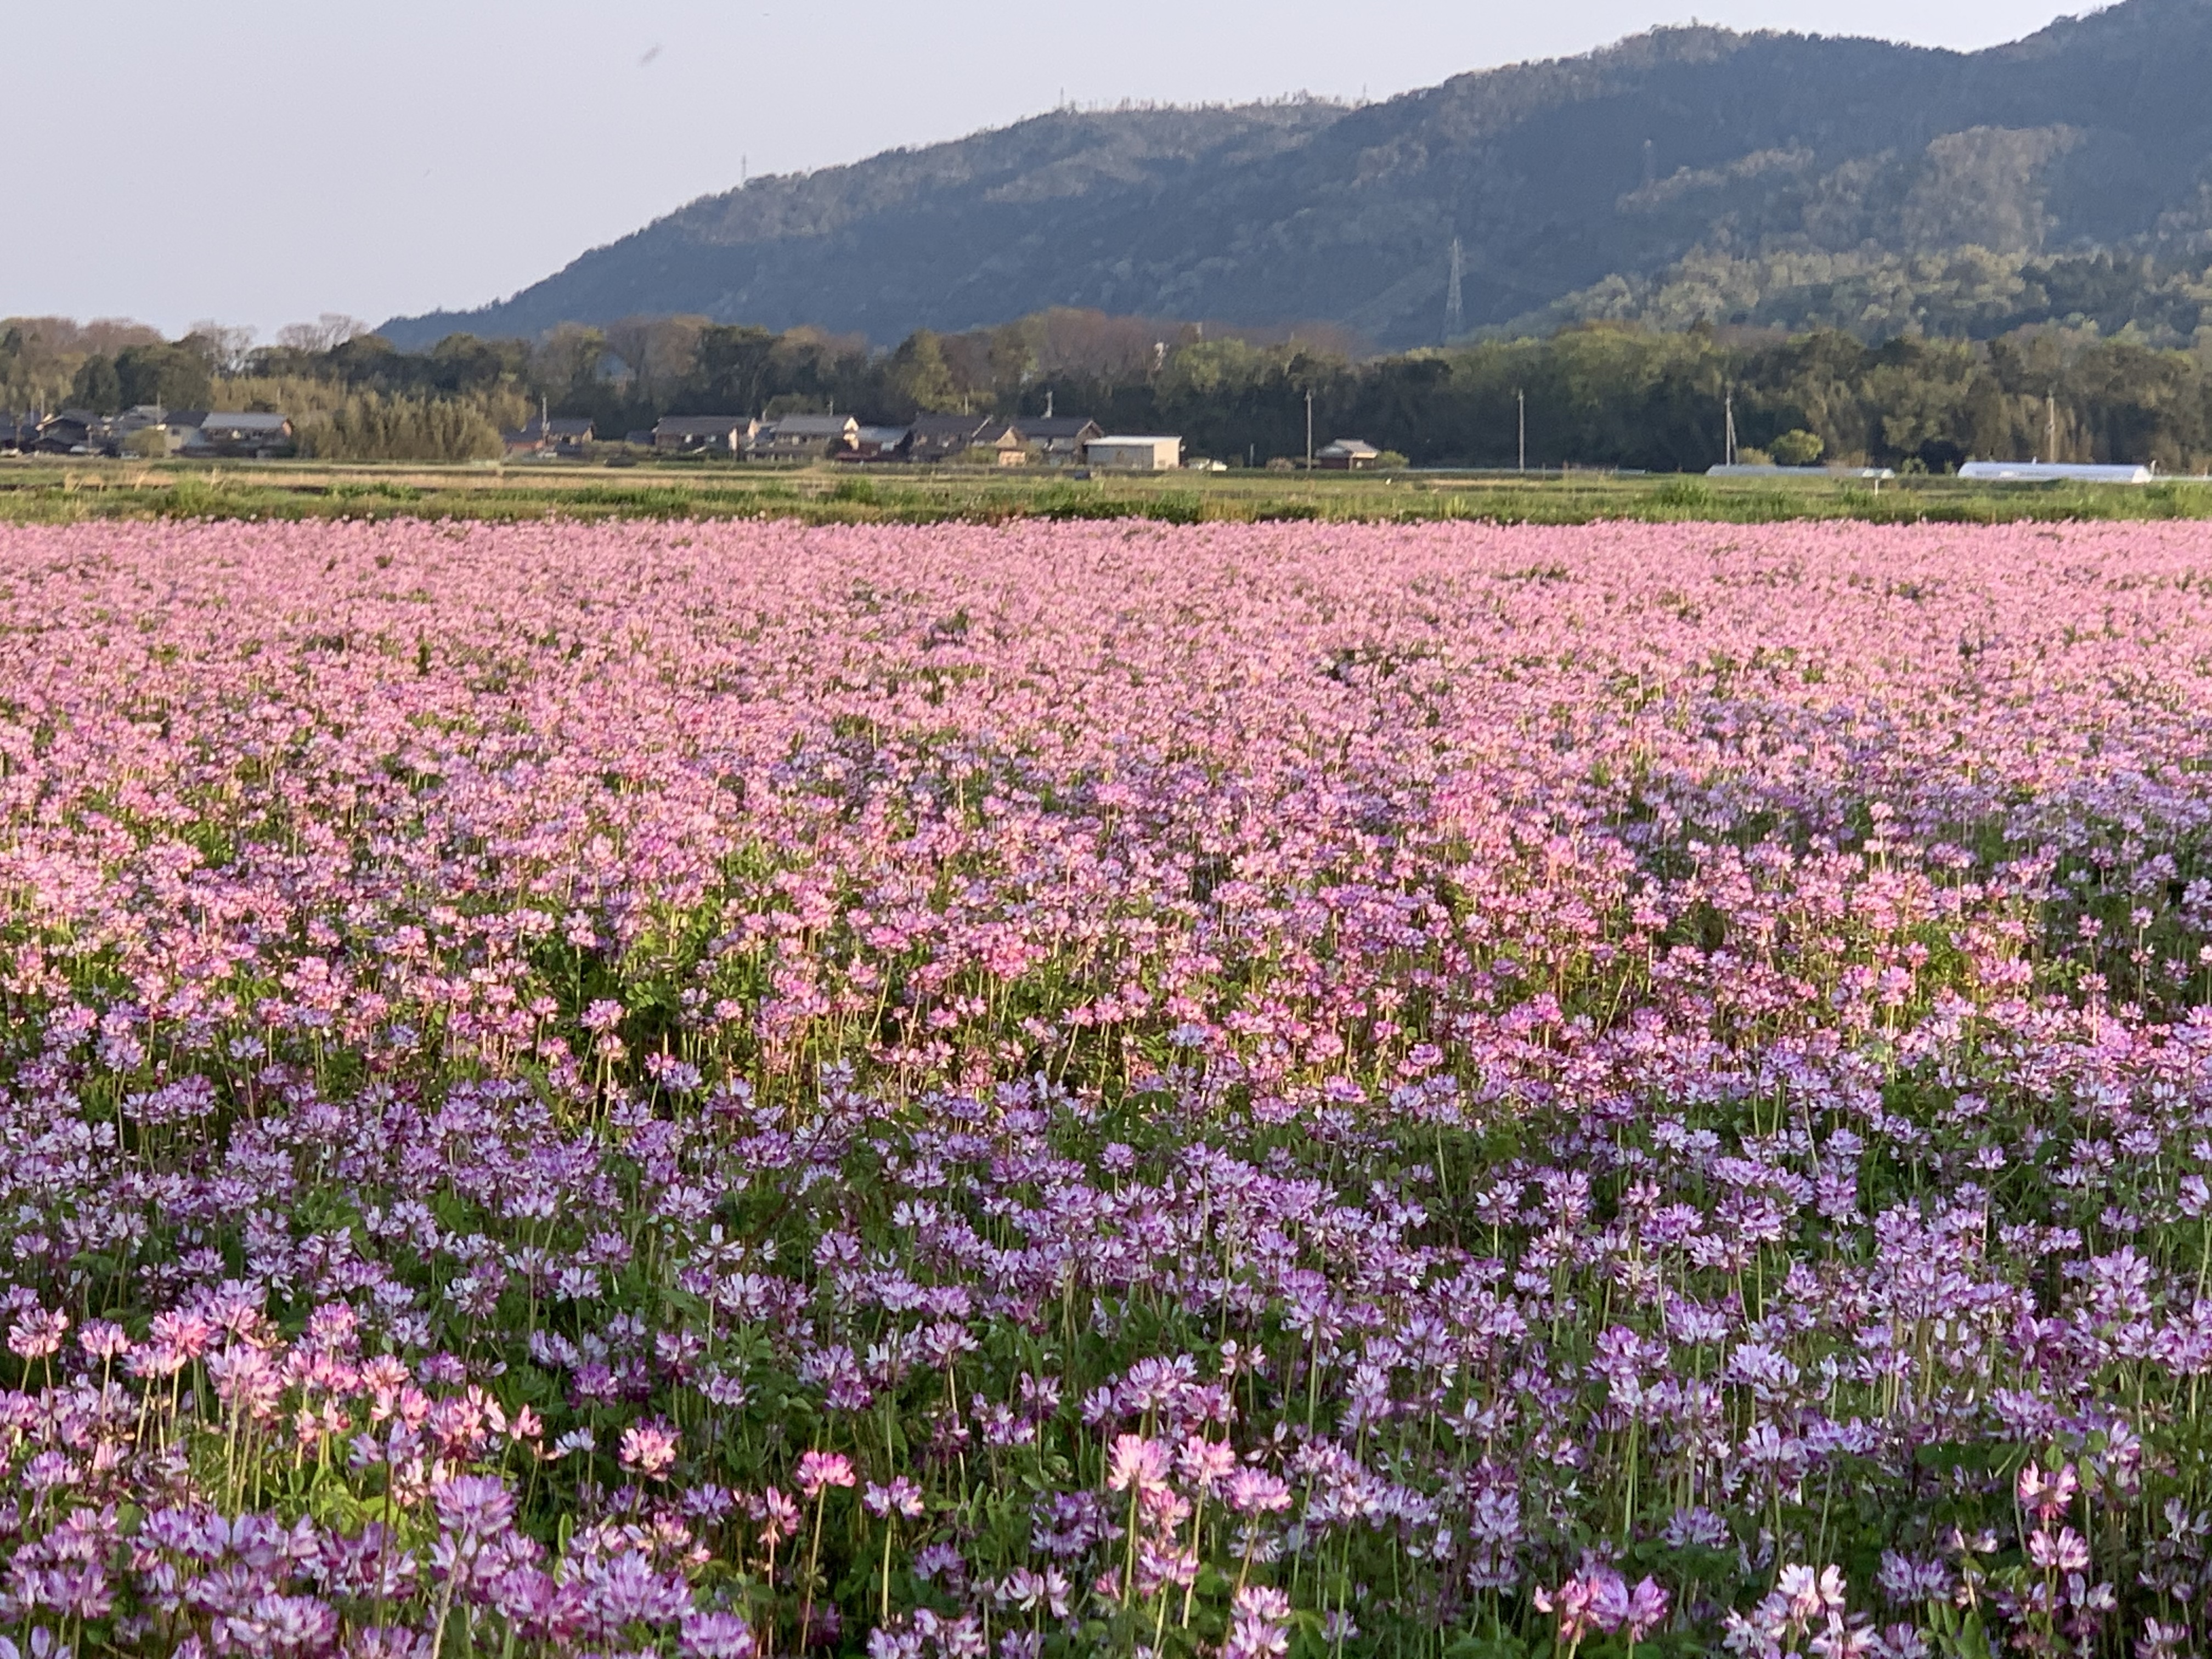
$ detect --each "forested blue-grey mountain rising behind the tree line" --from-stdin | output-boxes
[383,0,2212,347]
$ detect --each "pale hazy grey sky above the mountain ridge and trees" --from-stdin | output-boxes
[13,0,2079,332]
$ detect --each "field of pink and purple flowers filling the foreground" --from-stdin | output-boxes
[0,524,2212,1659]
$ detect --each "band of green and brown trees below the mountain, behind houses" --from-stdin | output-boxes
[0,312,2212,471]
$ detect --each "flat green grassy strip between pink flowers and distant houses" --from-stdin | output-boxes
[0,460,2212,524]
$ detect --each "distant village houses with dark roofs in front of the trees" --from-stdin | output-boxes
[0,405,1385,473]
